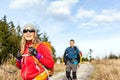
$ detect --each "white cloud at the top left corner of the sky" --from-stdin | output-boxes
[9,0,46,9]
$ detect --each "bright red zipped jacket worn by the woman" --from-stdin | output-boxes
[16,42,54,80]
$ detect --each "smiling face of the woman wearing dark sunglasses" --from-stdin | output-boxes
[23,27,35,41]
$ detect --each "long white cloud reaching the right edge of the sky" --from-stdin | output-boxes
[76,9,120,27]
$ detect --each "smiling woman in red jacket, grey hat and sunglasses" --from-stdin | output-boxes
[16,24,54,80]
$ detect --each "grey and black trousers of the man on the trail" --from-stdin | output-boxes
[66,63,77,80]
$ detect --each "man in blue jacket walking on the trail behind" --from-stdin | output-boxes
[63,39,80,80]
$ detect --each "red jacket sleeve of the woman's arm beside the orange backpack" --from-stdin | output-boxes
[37,43,54,68]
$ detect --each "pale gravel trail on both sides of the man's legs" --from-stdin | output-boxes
[50,63,94,80]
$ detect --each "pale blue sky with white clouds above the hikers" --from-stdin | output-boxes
[0,0,120,57]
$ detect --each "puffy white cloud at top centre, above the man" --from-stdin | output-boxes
[47,0,79,20]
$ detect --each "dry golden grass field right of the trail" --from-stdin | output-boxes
[90,59,120,80]
